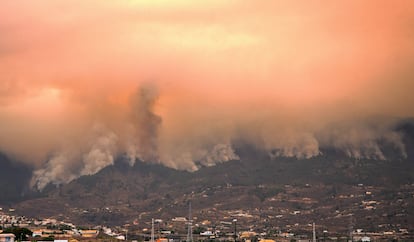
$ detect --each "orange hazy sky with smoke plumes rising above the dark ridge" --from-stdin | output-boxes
[0,0,414,188]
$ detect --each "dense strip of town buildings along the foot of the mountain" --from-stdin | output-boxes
[0,197,414,242]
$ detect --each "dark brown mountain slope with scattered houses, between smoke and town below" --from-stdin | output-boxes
[4,123,414,231]
